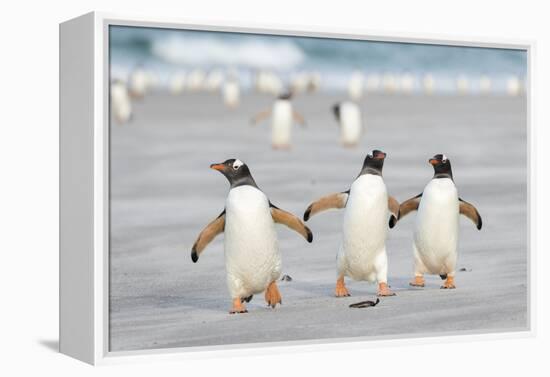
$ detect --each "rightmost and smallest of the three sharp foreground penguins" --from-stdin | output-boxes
[399,154,481,289]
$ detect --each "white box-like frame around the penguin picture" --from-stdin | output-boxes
[60,12,535,365]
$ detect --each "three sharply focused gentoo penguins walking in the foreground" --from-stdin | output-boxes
[191,150,482,314]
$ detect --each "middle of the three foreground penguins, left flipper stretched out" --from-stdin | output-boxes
[304,150,399,297]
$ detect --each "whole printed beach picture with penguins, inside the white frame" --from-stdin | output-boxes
[108,25,529,351]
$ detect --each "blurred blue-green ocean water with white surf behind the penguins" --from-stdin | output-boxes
[110,26,527,92]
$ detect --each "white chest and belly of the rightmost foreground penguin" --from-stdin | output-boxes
[414,178,459,274]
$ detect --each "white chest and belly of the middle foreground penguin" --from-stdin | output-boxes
[341,174,389,280]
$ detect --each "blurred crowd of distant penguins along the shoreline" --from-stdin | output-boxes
[110,65,524,151]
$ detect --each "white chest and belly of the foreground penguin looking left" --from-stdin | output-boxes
[225,185,281,297]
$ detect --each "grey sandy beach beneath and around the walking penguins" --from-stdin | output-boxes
[110,93,528,351]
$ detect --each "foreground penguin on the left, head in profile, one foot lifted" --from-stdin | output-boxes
[191,159,313,314]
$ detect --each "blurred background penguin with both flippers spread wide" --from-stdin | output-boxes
[251,91,306,149]
